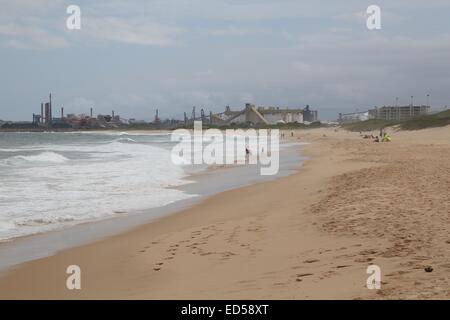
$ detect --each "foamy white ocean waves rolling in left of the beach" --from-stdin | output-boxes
[0,132,195,241]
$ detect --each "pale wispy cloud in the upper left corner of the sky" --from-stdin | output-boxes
[0,0,183,49]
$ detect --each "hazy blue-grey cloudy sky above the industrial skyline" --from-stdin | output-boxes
[0,0,450,120]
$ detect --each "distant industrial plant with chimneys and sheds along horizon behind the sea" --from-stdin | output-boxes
[0,93,318,131]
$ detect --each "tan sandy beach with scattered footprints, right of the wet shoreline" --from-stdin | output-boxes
[0,127,450,299]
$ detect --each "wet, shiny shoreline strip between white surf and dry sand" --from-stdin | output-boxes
[0,139,302,276]
